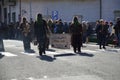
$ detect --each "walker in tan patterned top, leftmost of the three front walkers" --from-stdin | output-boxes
[20,18,31,52]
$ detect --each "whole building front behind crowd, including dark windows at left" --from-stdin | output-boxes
[0,0,120,23]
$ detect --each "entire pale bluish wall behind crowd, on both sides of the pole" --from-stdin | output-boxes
[10,0,120,22]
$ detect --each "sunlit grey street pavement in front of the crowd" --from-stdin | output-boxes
[0,40,120,80]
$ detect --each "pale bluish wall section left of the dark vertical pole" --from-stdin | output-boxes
[16,0,99,21]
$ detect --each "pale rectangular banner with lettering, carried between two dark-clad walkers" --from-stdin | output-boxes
[50,34,70,49]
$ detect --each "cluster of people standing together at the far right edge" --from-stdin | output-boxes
[95,18,120,49]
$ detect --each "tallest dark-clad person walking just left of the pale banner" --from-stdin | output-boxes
[34,14,47,56]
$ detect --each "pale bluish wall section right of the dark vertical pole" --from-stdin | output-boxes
[102,0,120,21]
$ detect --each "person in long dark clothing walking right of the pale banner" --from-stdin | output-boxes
[70,17,82,53]
